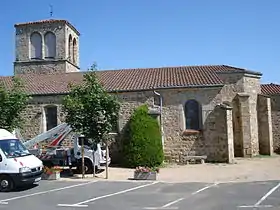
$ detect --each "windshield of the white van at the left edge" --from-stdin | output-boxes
[0,139,31,158]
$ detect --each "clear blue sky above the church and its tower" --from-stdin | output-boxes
[0,0,280,83]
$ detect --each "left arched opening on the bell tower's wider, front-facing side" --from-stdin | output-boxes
[30,32,42,59]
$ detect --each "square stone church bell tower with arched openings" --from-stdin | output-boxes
[14,19,80,75]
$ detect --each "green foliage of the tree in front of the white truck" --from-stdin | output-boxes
[63,65,120,146]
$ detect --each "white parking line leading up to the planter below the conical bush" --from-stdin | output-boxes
[57,182,159,207]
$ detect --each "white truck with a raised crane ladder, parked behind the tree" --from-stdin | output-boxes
[14,123,111,174]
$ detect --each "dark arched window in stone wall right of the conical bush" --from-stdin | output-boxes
[185,100,201,130]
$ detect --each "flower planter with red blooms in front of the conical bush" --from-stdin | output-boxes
[134,166,159,180]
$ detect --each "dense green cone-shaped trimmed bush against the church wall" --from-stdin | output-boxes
[123,105,164,168]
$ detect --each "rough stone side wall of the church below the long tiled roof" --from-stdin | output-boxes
[18,70,268,162]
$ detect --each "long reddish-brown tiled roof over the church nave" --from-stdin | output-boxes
[0,65,259,94]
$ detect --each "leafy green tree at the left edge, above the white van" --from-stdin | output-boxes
[0,77,31,132]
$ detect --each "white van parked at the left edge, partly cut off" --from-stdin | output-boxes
[0,129,43,192]
